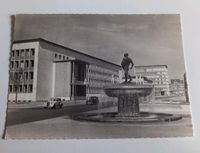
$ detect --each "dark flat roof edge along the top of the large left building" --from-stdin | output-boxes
[13,38,121,68]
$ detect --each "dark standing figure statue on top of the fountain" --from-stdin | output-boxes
[121,53,134,83]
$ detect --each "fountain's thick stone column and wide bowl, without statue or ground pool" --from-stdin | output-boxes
[104,83,153,117]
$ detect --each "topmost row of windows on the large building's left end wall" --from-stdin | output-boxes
[11,48,35,57]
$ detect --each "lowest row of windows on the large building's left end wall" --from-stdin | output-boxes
[9,84,33,93]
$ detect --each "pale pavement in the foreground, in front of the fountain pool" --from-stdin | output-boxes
[6,116,192,139]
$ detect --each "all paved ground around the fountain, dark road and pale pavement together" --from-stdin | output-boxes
[5,103,193,139]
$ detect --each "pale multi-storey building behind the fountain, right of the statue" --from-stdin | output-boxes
[135,65,170,97]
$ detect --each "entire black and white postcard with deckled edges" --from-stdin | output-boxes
[4,14,193,139]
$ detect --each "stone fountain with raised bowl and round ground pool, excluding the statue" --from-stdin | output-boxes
[72,76,182,123]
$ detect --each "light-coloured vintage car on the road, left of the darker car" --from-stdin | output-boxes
[43,98,63,109]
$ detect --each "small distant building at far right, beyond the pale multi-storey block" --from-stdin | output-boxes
[170,79,185,96]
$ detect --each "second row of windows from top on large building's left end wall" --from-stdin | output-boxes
[10,60,34,69]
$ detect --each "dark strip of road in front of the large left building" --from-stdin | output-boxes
[6,104,98,126]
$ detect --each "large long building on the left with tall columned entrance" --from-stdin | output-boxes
[8,39,121,101]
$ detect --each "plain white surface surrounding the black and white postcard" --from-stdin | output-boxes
[0,0,200,153]
